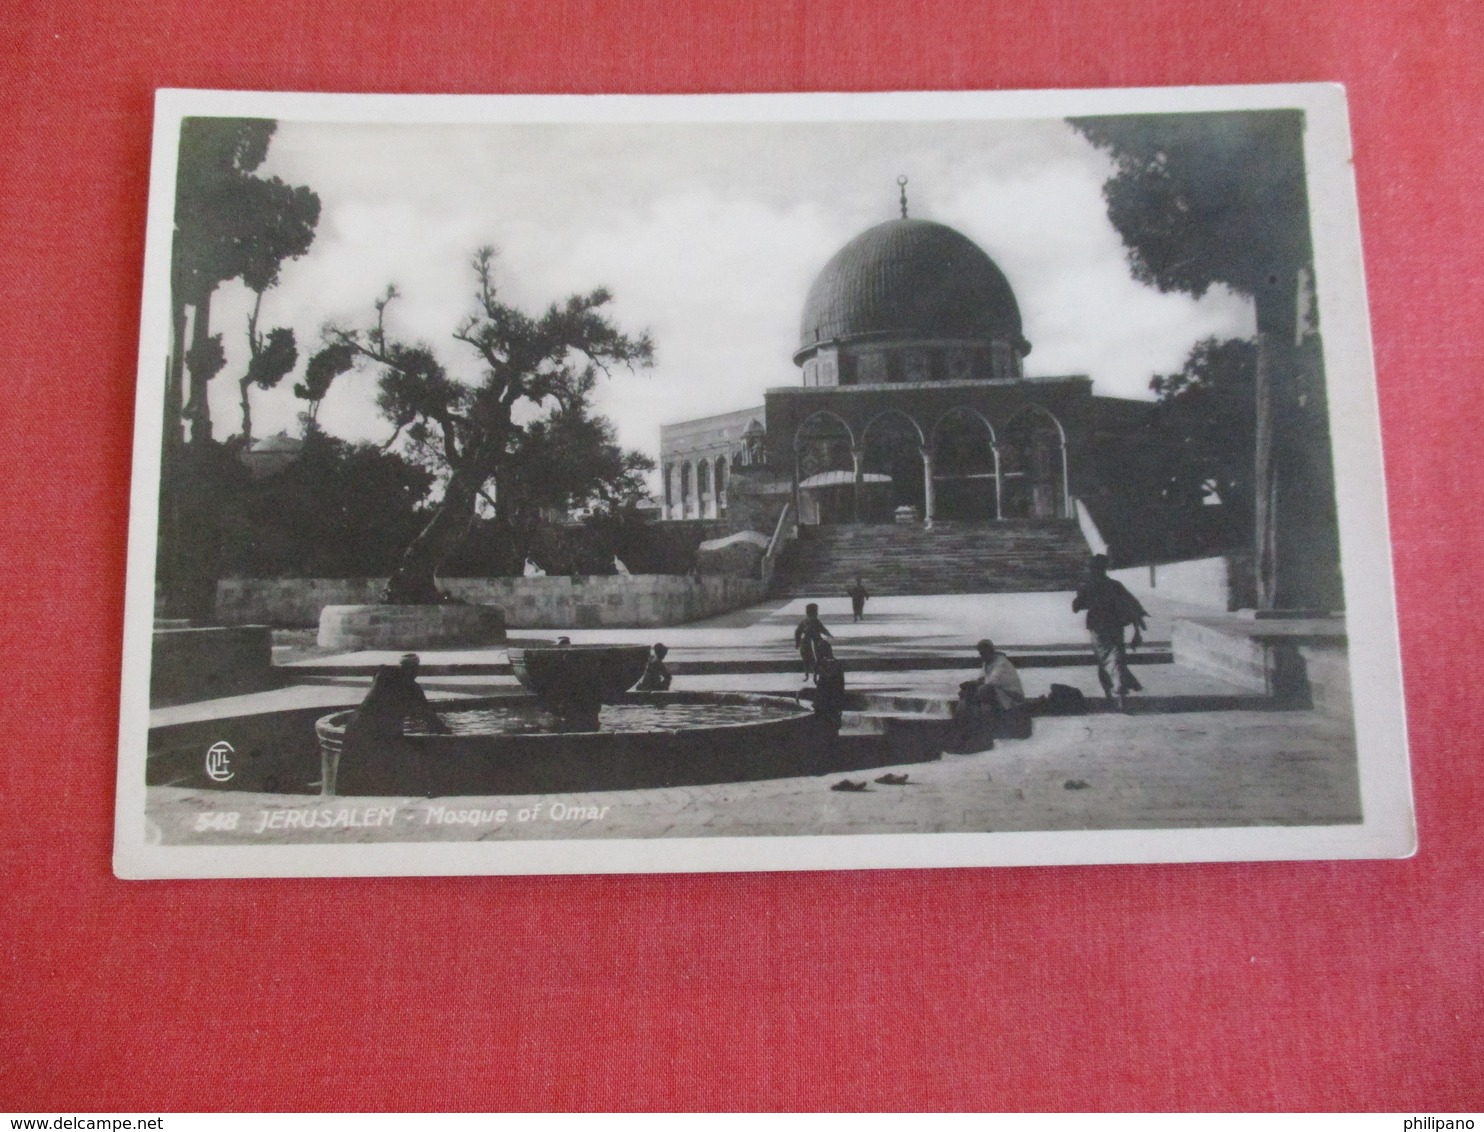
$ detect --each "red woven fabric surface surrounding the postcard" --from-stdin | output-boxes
[0,0,1484,1111]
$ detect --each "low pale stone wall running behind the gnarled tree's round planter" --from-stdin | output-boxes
[217,574,764,629]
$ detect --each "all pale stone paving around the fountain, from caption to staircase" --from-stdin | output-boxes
[147,593,1359,844]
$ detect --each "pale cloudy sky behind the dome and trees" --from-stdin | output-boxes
[211,119,1255,483]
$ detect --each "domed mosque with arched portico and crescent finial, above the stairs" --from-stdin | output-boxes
[660,178,1149,593]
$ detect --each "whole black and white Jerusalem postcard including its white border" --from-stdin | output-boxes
[114,85,1416,878]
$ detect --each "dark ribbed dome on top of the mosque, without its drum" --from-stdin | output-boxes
[794,218,1030,363]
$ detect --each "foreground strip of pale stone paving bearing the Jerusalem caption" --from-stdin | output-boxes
[148,711,1359,844]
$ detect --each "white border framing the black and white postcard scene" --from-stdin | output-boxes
[114,85,1416,878]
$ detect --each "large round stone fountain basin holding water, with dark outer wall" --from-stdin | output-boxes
[315,691,837,797]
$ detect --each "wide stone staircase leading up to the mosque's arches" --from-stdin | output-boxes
[773,519,1091,598]
